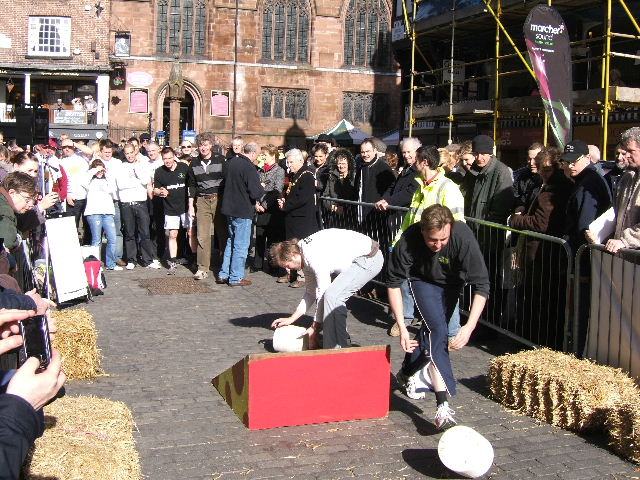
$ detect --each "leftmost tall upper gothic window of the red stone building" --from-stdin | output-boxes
[156,0,207,55]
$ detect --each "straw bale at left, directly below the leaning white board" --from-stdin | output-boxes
[52,309,104,380]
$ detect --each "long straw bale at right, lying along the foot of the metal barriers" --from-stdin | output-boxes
[488,349,637,432]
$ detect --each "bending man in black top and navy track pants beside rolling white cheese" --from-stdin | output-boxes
[387,204,489,430]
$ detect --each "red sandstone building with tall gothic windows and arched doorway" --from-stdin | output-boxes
[109,0,400,145]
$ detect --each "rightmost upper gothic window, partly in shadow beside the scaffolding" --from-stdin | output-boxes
[344,0,390,68]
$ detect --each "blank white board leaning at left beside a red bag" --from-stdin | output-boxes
[45,217,89,302]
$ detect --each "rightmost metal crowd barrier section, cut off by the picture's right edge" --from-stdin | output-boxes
[571,245,640,378]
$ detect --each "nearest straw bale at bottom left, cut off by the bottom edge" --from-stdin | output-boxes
[24,396,141,480]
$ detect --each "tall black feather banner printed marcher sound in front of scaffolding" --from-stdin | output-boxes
[524,5,573,148]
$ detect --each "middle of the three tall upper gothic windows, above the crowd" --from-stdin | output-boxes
[262,0,309,63]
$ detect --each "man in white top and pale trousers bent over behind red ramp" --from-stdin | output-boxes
[269,228,384,348]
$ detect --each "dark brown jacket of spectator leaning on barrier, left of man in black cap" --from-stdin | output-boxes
[509,170,574,261]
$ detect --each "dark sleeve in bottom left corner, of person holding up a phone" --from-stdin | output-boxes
[0,393,44,480]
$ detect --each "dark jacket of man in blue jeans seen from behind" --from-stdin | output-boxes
[220,155,264,218]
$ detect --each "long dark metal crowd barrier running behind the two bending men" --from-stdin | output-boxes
[320,197,572,350]
